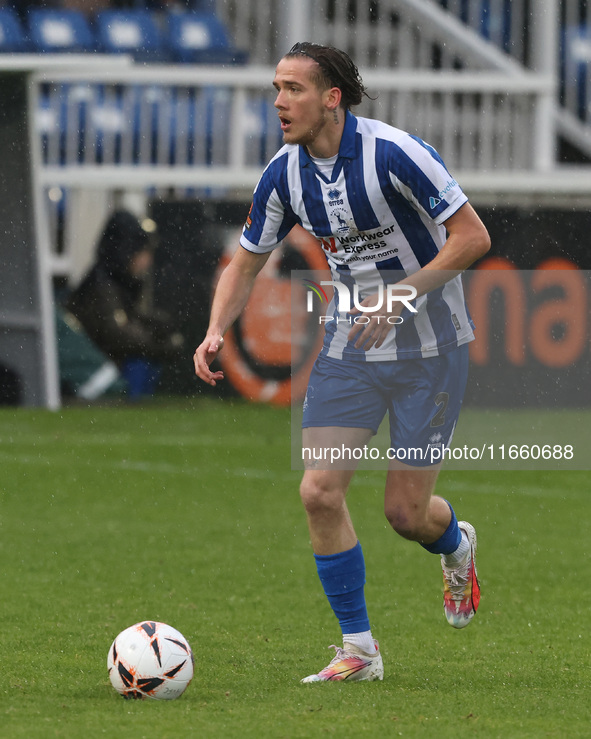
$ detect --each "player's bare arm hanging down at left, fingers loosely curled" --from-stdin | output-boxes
[193,246,271,386]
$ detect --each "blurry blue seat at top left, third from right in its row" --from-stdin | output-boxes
[28,8,95,53]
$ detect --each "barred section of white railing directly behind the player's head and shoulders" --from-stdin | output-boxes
[37,61,554,176]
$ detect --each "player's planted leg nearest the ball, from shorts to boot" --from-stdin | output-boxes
[300,358,386,682]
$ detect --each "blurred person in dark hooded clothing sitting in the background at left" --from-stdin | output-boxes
[66,211,184,398]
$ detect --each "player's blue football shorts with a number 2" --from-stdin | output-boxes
[302,344,469,467]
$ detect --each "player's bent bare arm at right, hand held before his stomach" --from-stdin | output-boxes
[349,203,490,351]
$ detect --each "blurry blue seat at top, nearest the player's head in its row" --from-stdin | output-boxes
[167,11,248,64]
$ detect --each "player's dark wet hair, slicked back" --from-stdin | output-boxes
[284,41,369,110]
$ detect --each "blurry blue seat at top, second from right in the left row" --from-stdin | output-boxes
[96,9,166,61]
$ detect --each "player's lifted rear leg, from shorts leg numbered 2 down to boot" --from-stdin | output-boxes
[385,346,480,628]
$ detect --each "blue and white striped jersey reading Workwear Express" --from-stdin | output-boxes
[240,113,474,361]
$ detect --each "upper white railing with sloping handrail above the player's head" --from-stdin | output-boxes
[216,0,591,156]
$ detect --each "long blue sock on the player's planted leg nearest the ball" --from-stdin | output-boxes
[314,542,369,634]
